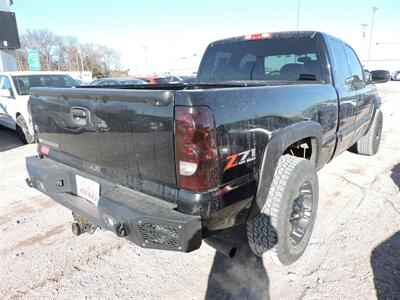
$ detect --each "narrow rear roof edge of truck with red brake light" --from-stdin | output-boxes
[212,31,325,44]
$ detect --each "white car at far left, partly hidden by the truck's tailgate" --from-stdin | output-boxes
[0,71,79,144]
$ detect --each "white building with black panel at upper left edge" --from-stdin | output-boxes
[0,0,21,72]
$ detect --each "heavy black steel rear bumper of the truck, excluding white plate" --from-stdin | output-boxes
[26,157,202,252]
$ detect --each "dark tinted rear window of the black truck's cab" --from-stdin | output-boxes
[199,38,324,82]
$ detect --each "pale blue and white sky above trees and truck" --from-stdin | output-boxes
[11,0,400,74]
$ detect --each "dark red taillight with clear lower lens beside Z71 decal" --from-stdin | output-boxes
[175,106,219,192]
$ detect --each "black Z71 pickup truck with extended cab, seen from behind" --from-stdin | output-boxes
[26,31,387,264]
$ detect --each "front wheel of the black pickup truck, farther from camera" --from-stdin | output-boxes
[352,109,383,156]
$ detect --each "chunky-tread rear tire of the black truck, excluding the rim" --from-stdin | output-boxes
[247,155,318,265]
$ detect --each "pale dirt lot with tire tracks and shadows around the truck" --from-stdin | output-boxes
[0,82,400,299]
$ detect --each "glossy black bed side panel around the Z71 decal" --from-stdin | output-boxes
[175,84,338,185]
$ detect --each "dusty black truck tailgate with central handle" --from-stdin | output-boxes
[30,88,176,186]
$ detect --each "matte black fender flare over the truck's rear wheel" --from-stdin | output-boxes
[248,121,322,219]
